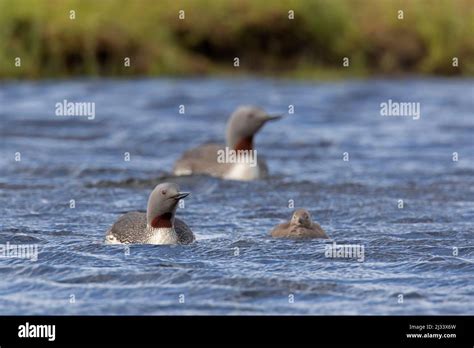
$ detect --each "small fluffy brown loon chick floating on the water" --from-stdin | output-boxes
[271,209,329,239]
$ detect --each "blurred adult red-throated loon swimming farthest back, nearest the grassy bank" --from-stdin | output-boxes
[173,106,281,180]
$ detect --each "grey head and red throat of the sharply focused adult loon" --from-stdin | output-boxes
[146,182,189,228]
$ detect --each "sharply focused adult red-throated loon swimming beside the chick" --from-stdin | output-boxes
[105,183,195,244]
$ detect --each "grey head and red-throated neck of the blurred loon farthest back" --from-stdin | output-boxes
[226,106,281,150]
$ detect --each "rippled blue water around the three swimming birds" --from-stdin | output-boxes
[0,79,474,314]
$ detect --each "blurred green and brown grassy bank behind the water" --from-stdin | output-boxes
[0,0,474,78]
